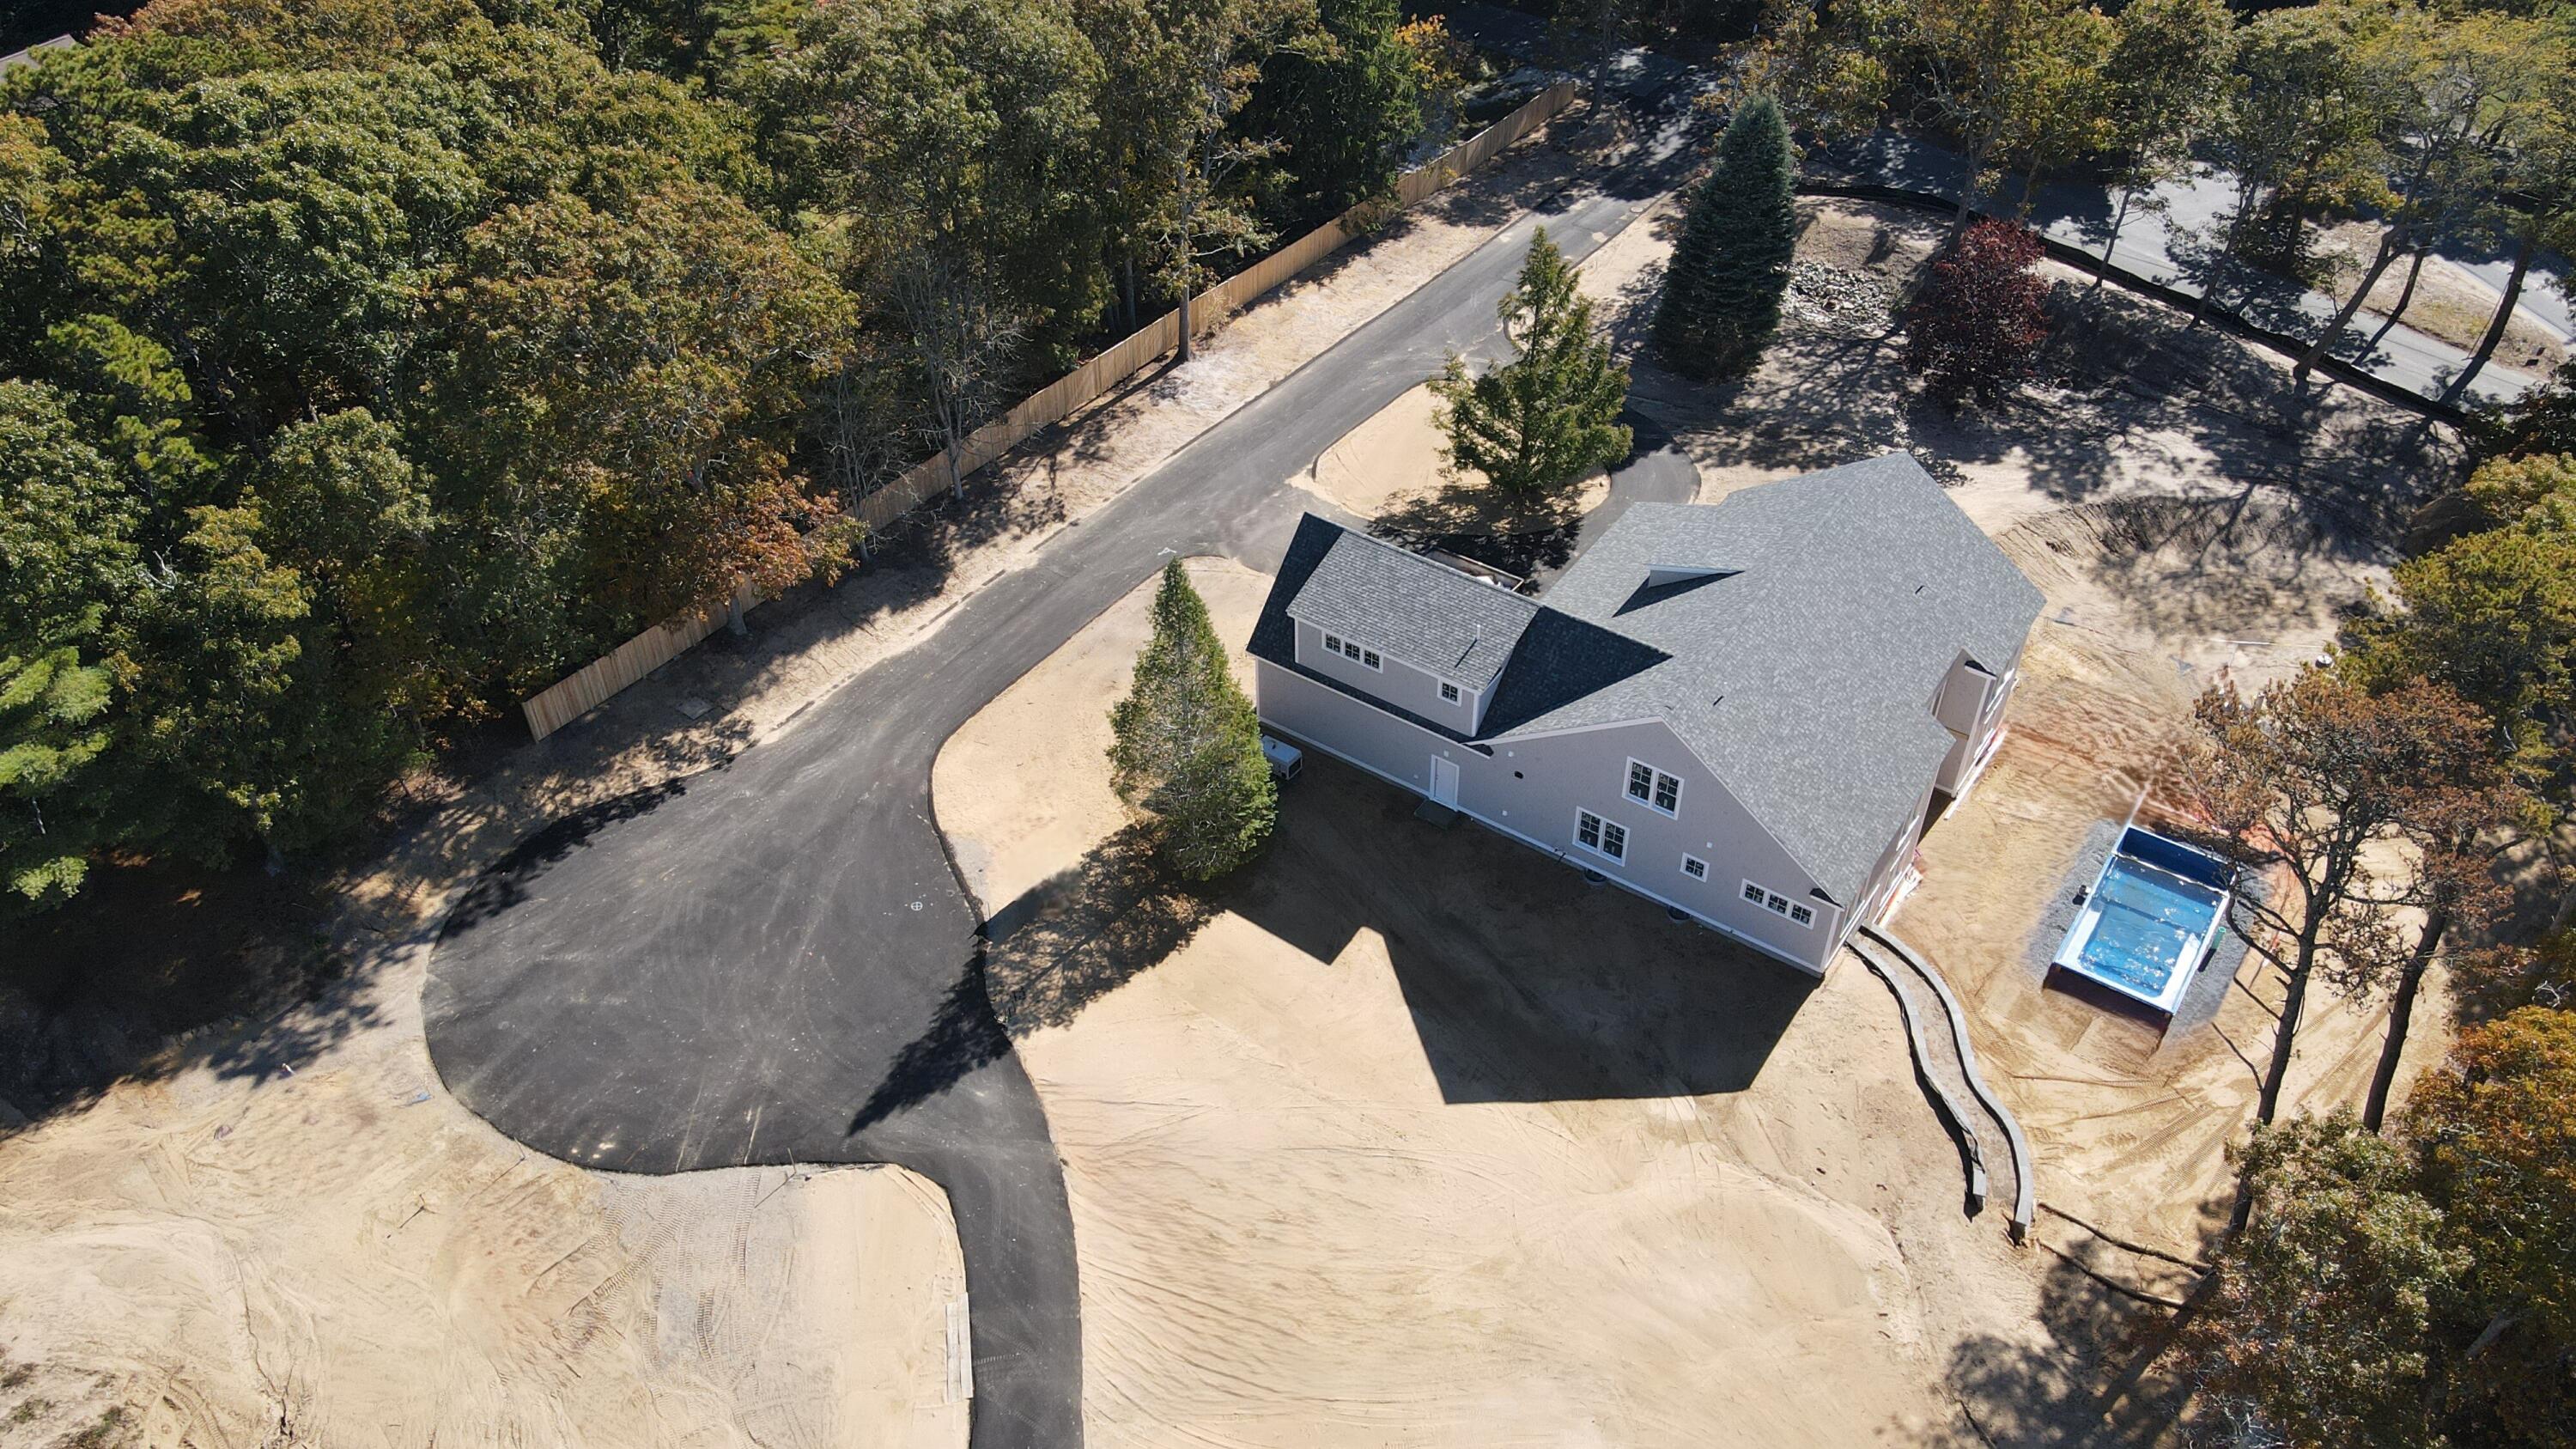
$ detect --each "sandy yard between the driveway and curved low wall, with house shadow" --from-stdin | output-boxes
[935,559,2053,1446]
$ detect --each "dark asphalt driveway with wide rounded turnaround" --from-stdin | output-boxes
[422,107,1685,1449]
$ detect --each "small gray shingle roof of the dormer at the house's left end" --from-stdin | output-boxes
[1288,531,1538,688]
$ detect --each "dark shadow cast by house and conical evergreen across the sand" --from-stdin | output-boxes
[850,756,1816,1132]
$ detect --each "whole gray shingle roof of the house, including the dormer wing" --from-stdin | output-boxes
[1255,454,2043,905]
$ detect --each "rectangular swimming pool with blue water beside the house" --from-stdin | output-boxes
[2050,828,2233,1016]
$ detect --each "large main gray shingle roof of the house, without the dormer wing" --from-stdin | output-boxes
[1515,454,2043,905]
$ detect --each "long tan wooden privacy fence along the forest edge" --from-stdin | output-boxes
[520,80,1574,740]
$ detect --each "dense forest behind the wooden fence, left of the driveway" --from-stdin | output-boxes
[0,0,1468,913]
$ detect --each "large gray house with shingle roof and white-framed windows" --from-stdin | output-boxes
[1252,454,2040,975]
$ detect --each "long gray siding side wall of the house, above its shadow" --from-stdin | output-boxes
[1255,657,1844,975]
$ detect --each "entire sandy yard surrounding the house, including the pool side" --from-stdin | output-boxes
[940,189,2458,1444]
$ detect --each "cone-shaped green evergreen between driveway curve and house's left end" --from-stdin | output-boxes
[1110,559,1278,880]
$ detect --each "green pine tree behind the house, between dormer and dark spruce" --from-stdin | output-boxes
[1432,229,1631,515]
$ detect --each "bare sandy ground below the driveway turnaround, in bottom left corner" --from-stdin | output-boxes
[0,953,966,1449]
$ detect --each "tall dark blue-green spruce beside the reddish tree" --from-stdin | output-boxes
[1654,95,1798,379]
